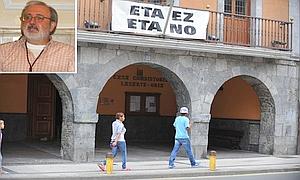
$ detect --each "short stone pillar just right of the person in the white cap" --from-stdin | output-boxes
[191,114,211,159]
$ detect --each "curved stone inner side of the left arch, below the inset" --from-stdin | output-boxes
[46,74,74,160]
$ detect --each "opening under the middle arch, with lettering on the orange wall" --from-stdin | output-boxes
[96,63,191,149]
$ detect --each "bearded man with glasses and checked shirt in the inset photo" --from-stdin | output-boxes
[0,1,75,72]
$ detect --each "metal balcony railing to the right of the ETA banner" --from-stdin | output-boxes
[207,11,293,51]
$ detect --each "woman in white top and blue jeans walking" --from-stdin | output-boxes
[98,112,130,171]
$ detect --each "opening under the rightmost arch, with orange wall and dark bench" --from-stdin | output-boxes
[209,75,275,154]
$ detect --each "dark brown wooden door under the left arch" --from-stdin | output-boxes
[28,75,56,141]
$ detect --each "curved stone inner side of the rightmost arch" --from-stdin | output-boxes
[210,75,275,154]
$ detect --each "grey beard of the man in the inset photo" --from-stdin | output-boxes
[22,25,50,41]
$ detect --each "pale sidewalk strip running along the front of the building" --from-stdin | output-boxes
[0,155,300,180]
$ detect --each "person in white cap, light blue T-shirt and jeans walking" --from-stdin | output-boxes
[169,107,199,169]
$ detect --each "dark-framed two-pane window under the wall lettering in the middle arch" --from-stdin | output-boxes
[125,92,160,115]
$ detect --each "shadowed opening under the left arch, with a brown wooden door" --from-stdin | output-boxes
[0,74,73,163]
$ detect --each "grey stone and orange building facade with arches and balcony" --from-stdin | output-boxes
[0,0,300,162]
